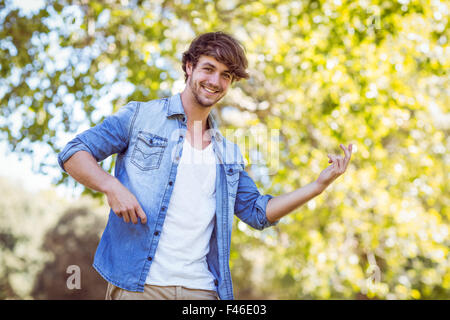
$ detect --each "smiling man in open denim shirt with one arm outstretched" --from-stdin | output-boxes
[58,32,351,299]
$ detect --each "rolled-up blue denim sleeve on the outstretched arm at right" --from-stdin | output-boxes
[234,171,278,230]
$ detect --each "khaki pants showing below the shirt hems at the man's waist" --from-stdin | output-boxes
[105,282,219,300]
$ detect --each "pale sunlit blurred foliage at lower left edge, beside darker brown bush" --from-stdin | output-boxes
[0,177,67,299]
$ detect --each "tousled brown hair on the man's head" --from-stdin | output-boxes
[182,31,249,81]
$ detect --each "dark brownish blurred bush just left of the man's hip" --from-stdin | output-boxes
[32,208,107,300]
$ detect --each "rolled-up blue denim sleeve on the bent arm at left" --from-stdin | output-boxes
[58,102,138,171]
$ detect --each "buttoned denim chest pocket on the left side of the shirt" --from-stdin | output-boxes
[131,131,167,171]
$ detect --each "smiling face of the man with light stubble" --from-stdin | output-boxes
[186,56,233,107]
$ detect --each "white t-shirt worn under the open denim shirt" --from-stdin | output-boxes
[146,139,216,290]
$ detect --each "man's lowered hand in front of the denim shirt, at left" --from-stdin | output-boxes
[105,179,147,224]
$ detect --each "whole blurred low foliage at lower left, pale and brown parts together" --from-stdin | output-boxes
[0,178,107,300]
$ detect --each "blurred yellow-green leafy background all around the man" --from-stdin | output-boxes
[0,0,450,299]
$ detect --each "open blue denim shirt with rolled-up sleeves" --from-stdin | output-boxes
[58,94,277,300]
